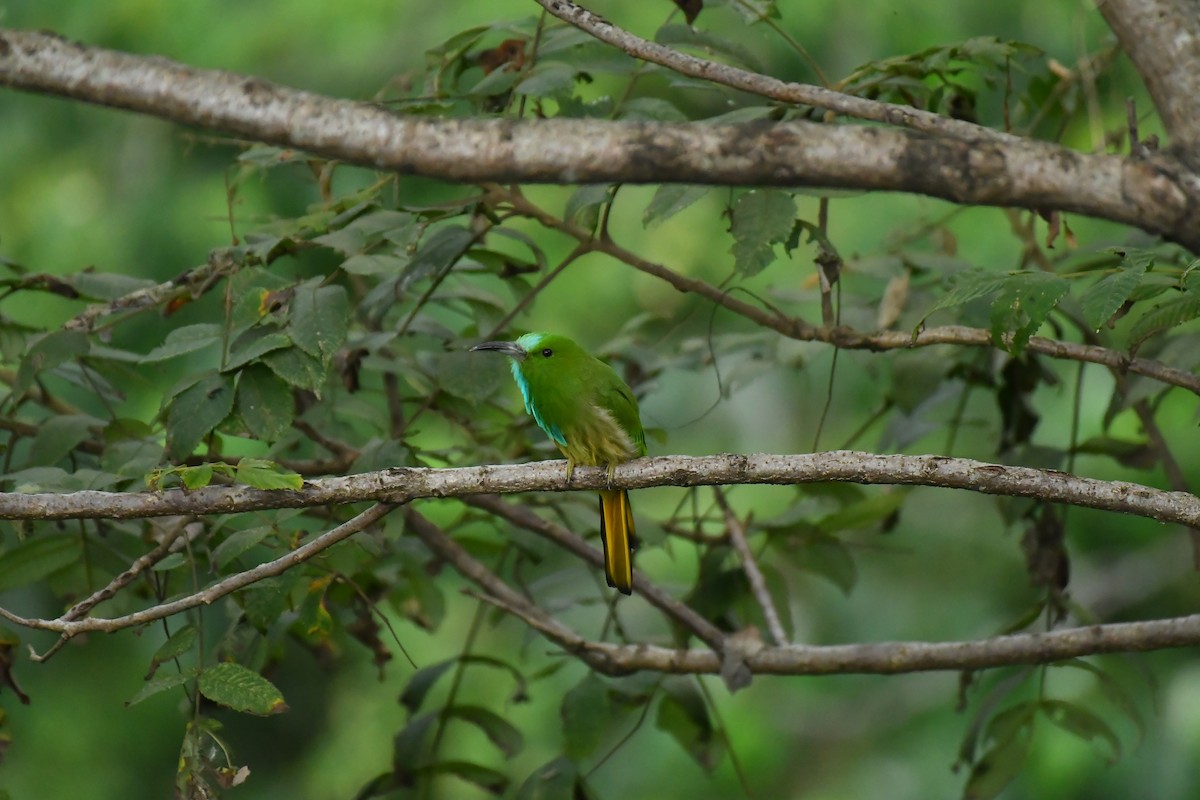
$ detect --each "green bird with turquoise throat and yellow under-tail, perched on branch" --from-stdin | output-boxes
[472,333,646,595]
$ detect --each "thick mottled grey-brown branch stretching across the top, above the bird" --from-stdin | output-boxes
[7,30,1200,252]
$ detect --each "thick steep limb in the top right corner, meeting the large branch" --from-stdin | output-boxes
[1097,0,1200,160]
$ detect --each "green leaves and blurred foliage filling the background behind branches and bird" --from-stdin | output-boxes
[0,0,1200,799]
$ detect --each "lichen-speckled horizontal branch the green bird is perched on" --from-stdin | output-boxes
[0,450,1200,528]
